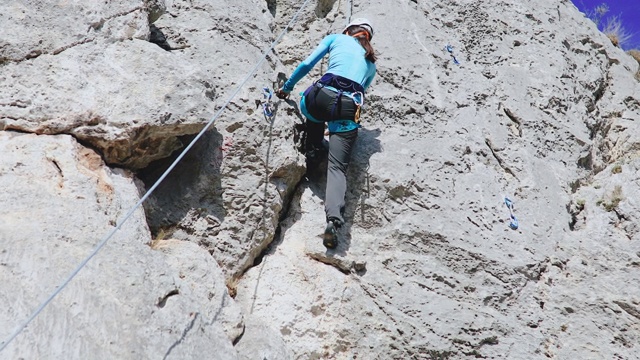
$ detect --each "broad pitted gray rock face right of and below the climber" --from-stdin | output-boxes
[238,1,640,359]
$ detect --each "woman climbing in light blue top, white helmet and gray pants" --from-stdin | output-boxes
[276,18,376,249]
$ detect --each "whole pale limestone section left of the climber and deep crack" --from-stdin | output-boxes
[0,1,292,359]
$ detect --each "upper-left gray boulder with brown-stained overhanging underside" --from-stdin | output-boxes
[0,0,278,169]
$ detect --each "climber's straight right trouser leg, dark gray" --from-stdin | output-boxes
[324,129,358,225]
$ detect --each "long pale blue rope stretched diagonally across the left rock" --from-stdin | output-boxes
[0,0,310,351]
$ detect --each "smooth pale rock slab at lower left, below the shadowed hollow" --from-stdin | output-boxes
[0,132,242,359]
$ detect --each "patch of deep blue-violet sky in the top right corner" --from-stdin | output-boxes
[572,0,640,50]
